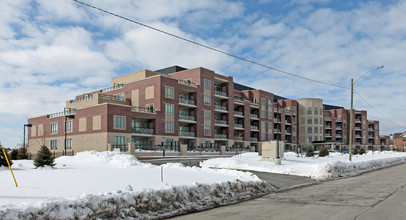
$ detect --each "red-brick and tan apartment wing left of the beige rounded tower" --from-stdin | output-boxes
[28,66,298,154]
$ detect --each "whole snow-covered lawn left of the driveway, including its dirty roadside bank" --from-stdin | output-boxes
[0,151,272,219]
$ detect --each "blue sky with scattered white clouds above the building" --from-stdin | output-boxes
[0,0,406,148]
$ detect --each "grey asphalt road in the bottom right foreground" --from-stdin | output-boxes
[173,164,406,220]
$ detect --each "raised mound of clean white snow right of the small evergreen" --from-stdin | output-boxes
[55,151,143,168]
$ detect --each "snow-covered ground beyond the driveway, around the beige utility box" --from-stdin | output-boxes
[200,151,406,180]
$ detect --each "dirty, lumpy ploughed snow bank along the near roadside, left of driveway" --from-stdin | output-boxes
[0,181,274,220]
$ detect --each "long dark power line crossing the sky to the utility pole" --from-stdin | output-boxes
[72,0,350,89]
